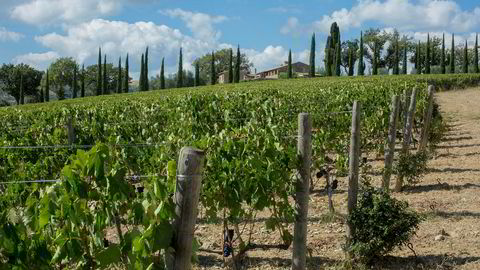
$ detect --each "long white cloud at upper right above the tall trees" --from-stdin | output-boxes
[313,0,480,33]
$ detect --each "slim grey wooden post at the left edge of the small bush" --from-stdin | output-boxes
[347,101,361,253]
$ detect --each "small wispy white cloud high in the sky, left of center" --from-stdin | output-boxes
[160,8,227,43]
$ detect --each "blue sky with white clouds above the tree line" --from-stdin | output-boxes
[0,0,480,77]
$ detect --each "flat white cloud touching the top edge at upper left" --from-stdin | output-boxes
[10,0,124,25]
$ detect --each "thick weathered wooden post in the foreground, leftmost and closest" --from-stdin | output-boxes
[173,147,205,270]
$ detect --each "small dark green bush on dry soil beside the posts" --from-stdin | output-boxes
[347,186,421,264]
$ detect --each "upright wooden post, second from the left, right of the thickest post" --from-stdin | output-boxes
[292,113,312,270]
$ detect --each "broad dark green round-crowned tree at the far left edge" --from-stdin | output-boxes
[0,64,43,104]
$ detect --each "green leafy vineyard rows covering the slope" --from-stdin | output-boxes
[0,74,480,269]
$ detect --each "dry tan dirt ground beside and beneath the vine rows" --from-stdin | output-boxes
[195,88,480,269]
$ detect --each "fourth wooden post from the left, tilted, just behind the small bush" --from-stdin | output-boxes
[382,95,400,192]
